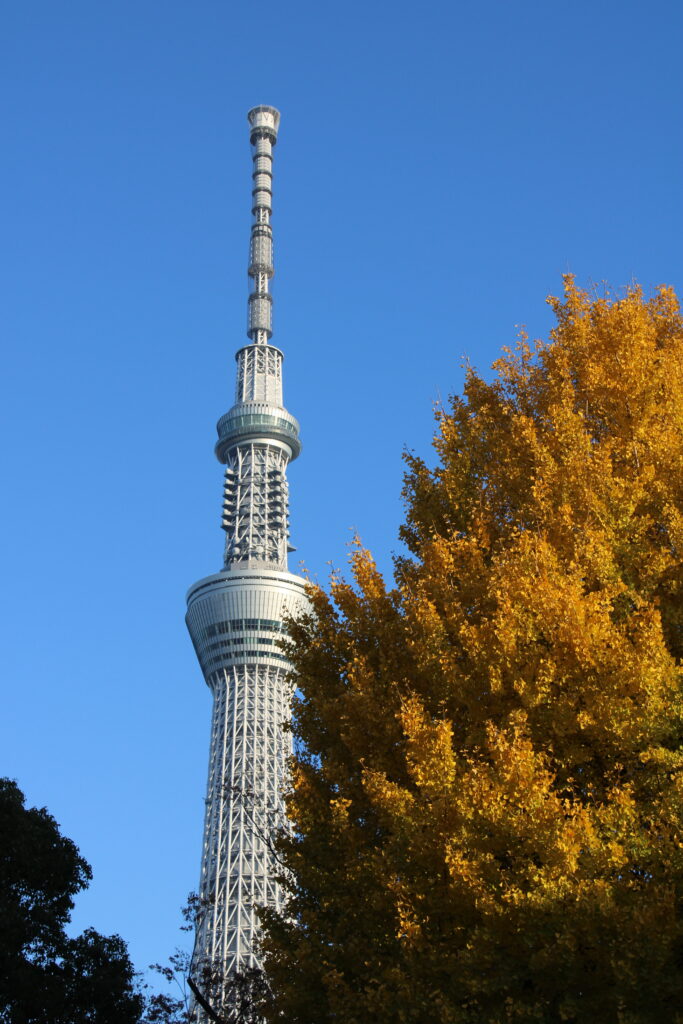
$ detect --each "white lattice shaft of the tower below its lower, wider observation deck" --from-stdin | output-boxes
[197,665,291,971]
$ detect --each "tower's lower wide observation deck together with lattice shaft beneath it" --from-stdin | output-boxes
[186,569,308,998]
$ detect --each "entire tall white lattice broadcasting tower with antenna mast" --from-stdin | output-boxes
[186,106,307,998]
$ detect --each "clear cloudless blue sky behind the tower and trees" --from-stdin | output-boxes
[0,0,683,991]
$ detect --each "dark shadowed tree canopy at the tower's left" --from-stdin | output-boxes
[0,778,143,1024]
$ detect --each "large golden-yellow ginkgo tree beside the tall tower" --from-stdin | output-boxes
[264,279,683,1024]
